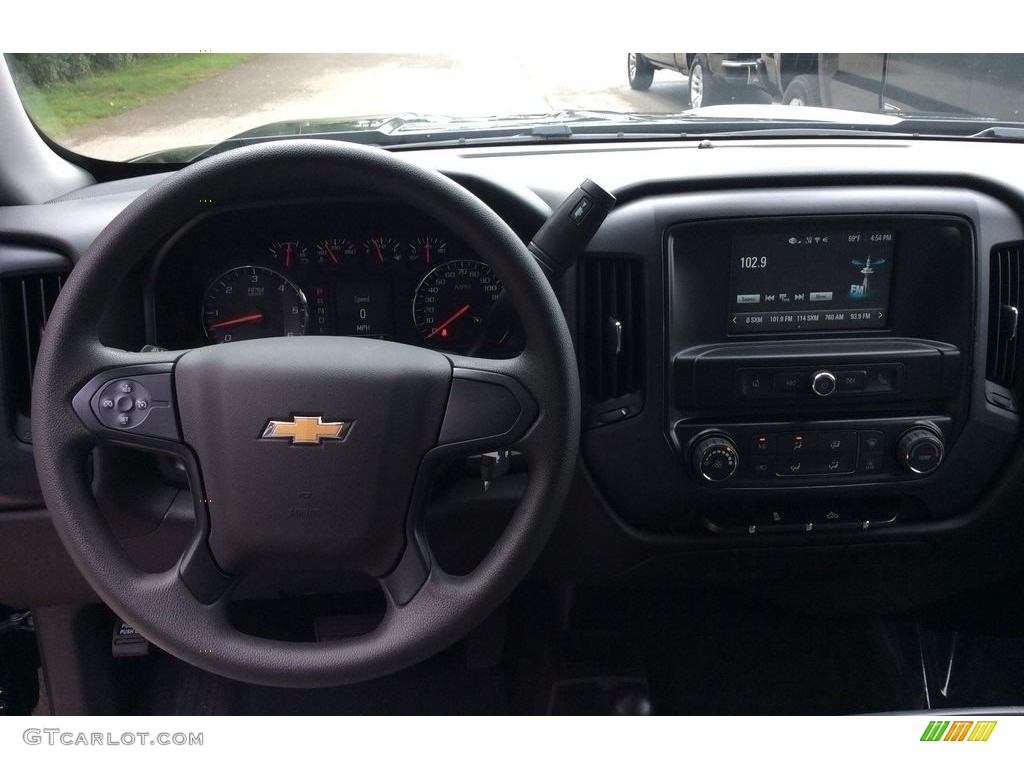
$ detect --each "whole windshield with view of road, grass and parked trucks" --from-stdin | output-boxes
[5,50,1024,162]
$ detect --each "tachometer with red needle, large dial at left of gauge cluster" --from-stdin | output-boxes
[203,266,308,344]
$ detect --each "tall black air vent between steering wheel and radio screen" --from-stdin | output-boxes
[581,257,644,426]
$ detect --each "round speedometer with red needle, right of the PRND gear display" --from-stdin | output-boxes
[413,259,502,350]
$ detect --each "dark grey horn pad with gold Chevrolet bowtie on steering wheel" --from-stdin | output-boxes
[174,338,452,575]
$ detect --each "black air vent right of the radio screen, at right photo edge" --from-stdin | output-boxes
[986,243,1024,411]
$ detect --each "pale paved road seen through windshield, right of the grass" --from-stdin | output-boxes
[66,52,700,160]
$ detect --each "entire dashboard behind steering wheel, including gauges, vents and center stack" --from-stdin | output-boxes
[0,140,1024,607]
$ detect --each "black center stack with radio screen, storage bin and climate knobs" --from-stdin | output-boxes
[666,210,975,530]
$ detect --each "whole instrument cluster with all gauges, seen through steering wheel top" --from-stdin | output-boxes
[148,201,521,356]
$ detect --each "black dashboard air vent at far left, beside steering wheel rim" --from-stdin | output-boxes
[0,272,67,442]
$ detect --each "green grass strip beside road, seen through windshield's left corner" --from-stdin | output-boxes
[22,53,257,138]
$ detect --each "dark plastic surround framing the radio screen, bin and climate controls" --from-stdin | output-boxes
[583,185,1024,549]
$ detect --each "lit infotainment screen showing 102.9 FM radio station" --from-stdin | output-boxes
[729,229,895,334]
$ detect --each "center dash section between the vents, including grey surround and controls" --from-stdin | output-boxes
[585,184,1022,547]
